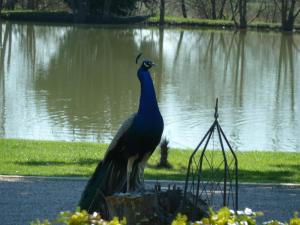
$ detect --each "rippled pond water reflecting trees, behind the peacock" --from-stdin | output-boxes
[0,23,300,152]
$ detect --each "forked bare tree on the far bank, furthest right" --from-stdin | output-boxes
[275,0,300,31]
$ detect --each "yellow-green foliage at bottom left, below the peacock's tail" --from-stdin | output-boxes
[31,209,126,225]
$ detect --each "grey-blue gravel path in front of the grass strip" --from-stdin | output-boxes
[0,176,300,225]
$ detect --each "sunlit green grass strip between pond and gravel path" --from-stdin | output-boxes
[0,139,300,183]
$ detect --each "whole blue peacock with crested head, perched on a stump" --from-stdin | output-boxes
[79,54,164,213]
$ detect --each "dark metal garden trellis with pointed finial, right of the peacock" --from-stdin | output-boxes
[183,99,238,211]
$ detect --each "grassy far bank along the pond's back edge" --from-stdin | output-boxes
[0,11,300,32]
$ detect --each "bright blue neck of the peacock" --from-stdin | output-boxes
[138,68,159,115]
